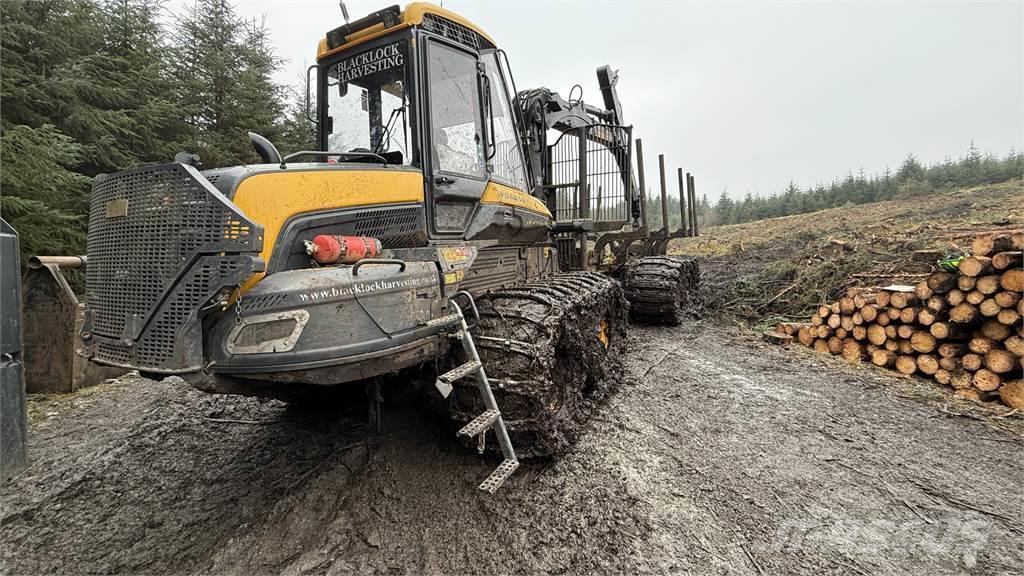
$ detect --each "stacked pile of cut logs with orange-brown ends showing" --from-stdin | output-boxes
[776,232,1024,410]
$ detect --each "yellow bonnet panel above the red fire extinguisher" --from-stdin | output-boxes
[233,169,423,291]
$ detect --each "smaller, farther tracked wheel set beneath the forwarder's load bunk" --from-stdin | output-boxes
[623,256,700,325]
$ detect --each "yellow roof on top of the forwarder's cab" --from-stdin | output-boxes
[316,2,496,60]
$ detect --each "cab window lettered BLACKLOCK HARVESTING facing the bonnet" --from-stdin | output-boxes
[327,40,414,164]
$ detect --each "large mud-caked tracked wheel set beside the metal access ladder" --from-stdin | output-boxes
[449,273,629,457]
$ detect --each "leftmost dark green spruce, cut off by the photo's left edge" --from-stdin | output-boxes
[0,0,99,256]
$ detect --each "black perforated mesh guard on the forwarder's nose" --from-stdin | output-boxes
[86,163,263,372]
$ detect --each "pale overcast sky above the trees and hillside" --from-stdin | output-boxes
[186,0,1024,199]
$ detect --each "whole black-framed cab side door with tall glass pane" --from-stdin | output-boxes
[423,35,487,238]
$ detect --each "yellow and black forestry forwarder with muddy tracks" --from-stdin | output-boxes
[81,3,693,491]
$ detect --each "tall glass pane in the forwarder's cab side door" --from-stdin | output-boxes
[427,42,486,179]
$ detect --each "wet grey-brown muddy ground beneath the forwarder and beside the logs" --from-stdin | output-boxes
[0,323,1024,575]
